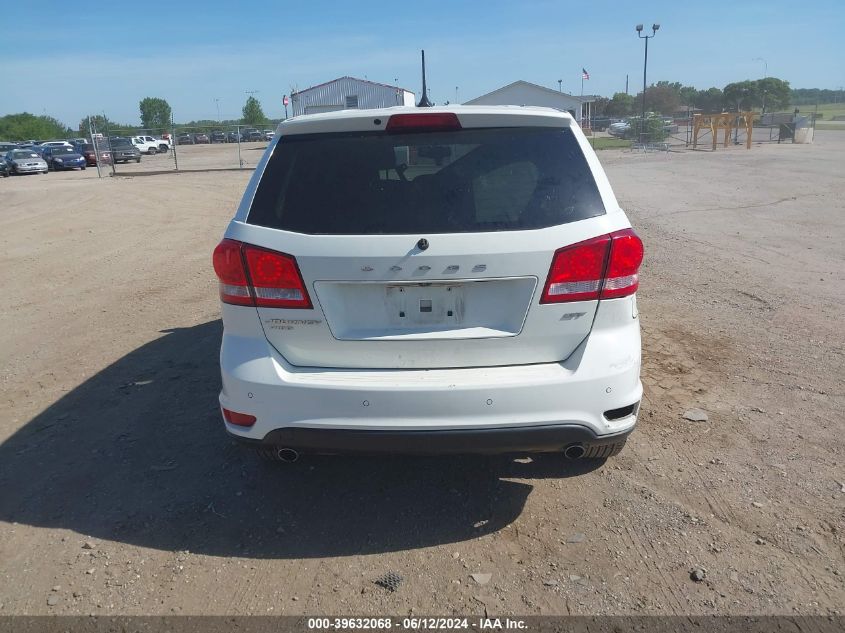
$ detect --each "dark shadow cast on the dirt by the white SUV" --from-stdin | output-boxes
[0,321,600,558]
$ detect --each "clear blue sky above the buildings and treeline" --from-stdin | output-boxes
[0,0,845,127]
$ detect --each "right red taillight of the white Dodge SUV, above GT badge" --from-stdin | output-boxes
[540,229,643,303]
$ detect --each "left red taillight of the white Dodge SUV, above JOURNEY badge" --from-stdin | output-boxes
[213,239,311,308]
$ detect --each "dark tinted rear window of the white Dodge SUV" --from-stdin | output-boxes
[247,128,605,235]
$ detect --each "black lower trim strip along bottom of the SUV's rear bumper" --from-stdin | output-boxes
[227,424,632,457]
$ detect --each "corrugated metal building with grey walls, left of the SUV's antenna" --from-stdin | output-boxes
[290,77,414,116]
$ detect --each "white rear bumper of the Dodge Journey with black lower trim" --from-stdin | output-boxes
[220,299,642,453]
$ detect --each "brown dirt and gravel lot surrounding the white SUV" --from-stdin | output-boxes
[0,131,845,615]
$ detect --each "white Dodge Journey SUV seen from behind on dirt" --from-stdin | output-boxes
[213,106,643,460]
